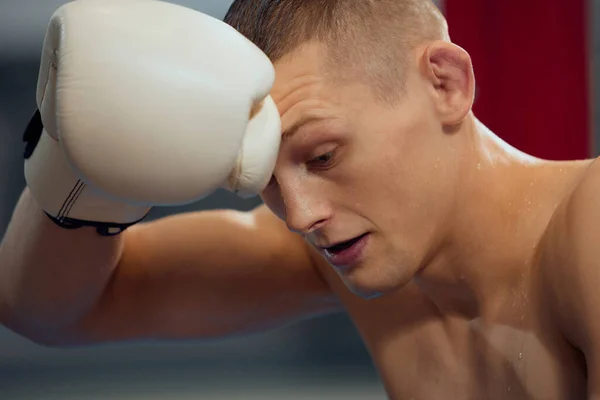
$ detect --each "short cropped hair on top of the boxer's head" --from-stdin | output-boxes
[224,0,450,99]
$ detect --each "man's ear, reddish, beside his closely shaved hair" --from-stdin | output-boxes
[421,41,475,125]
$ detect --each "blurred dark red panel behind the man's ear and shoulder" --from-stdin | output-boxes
[444,0,592,160]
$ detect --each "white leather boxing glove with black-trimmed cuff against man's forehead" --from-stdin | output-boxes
[24,0,281,235]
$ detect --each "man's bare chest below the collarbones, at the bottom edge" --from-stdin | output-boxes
[356,302,586,400]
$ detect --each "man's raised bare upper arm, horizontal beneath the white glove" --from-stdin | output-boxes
[72,207,338,341]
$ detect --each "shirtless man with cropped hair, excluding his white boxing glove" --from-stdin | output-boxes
[0,0,600,399]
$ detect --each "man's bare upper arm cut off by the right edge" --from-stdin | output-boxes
[548,165,600,398]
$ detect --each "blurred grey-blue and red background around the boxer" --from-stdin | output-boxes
[0,0,600,400]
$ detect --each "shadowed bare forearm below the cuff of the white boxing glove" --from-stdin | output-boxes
[0,190,123,342]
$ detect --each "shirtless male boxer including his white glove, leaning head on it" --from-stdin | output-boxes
[0,0,600,399]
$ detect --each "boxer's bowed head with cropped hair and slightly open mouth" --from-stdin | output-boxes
[225,0,474,296]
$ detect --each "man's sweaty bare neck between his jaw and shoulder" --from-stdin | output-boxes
[415,117,581,318]
